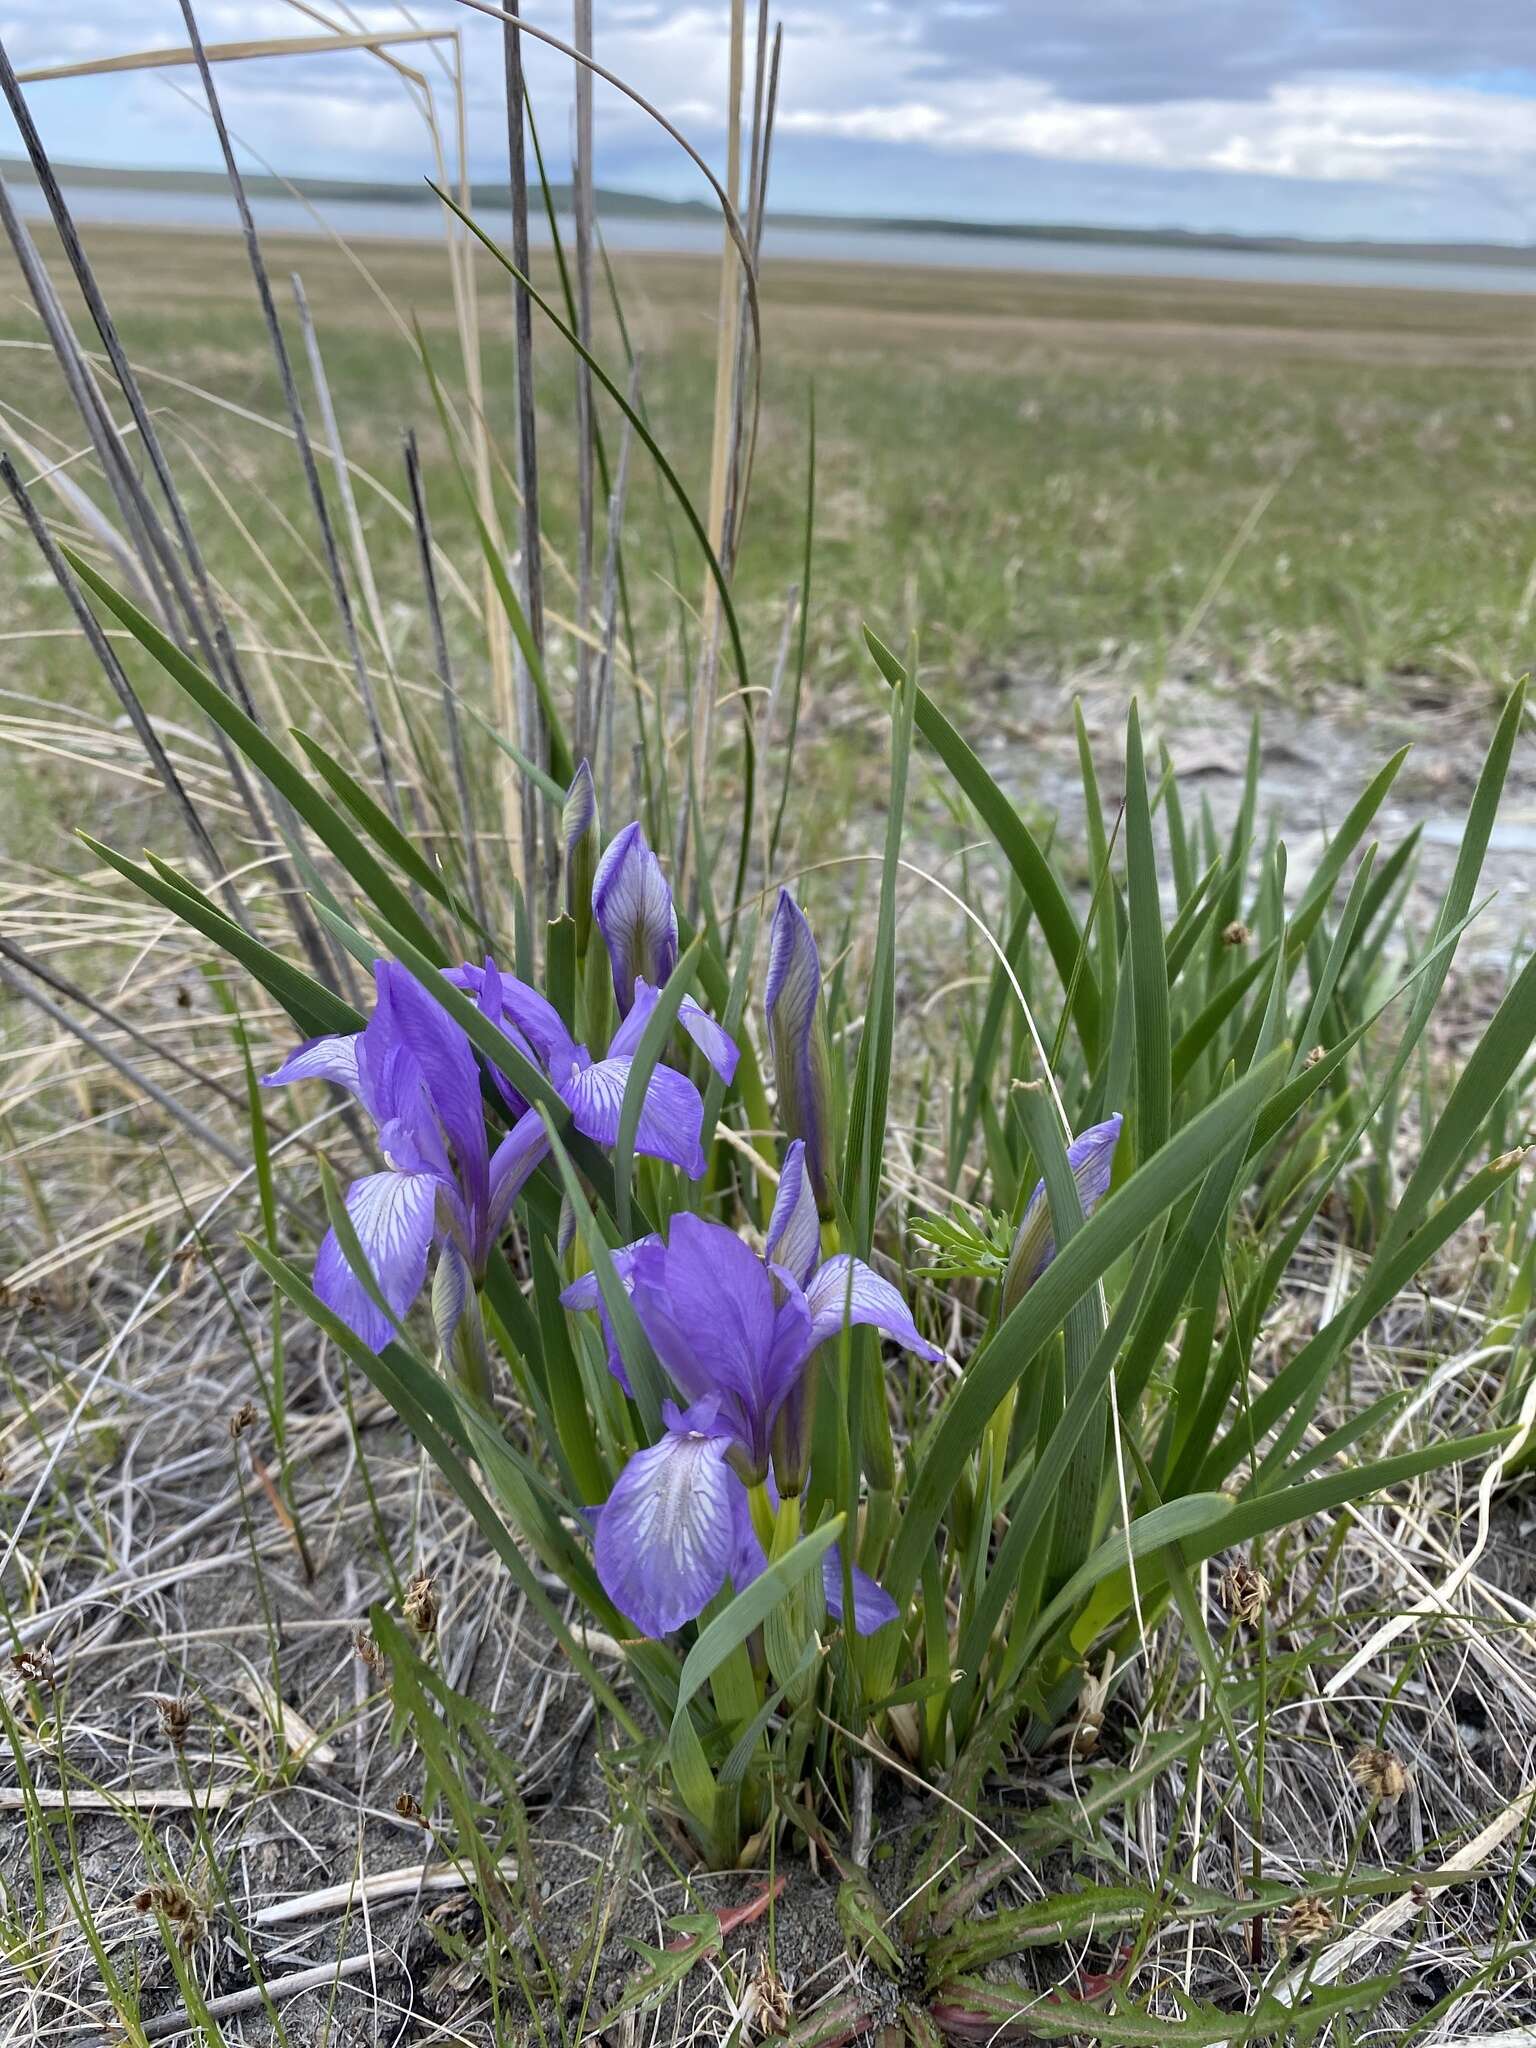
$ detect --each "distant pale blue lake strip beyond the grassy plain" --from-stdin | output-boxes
[12,180,1536,293]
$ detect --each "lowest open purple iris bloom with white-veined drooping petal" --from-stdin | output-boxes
[561,1145,942,1636]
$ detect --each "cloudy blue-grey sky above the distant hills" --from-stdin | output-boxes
[0,0,1536,242]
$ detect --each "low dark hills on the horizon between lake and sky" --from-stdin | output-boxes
[0,156,1536,270]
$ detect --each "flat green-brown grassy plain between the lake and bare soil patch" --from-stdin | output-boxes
[0,229,1536,720]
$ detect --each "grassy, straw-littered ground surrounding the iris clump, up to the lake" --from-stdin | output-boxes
[0,216,1536,2048]
